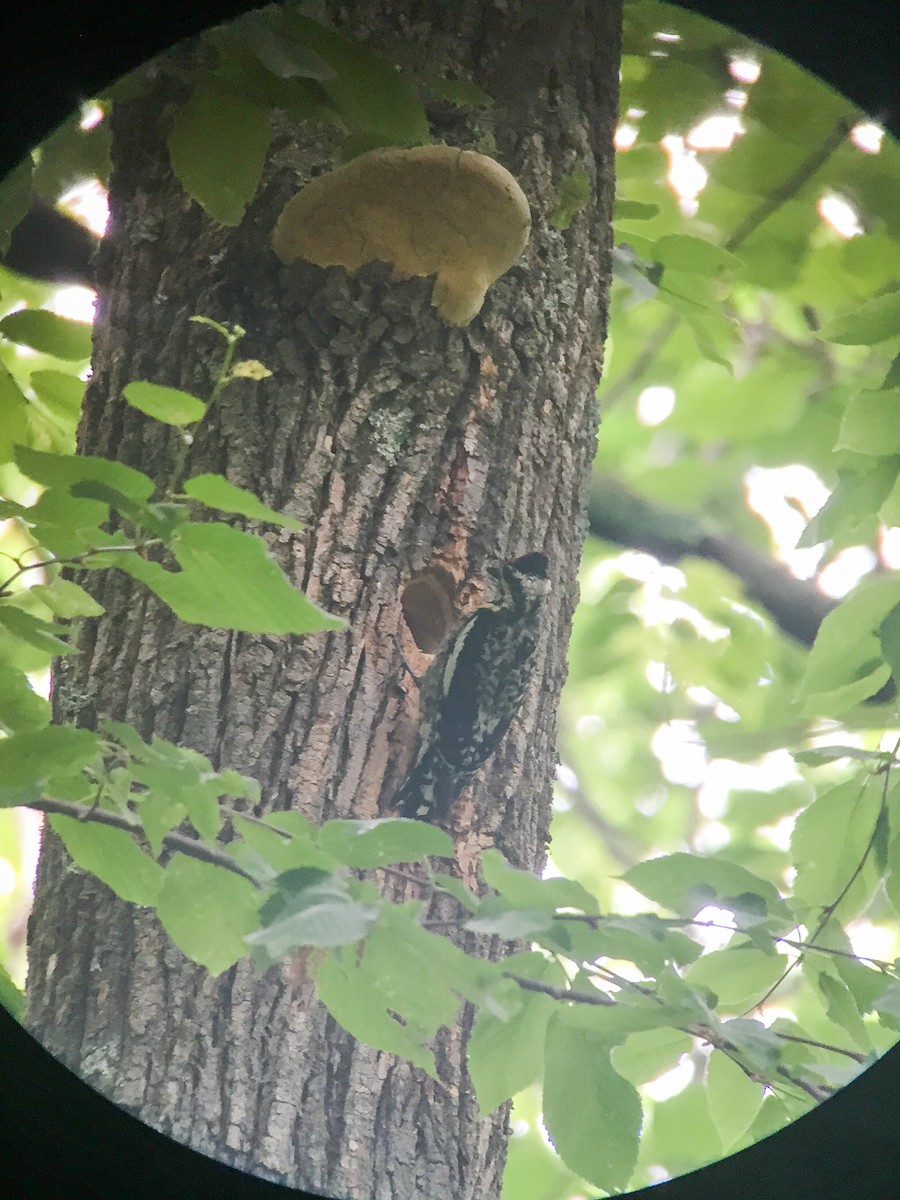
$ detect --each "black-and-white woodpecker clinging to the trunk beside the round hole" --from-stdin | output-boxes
[391,551,550,821]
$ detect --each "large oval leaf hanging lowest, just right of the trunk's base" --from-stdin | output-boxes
[544,1009,642,1192]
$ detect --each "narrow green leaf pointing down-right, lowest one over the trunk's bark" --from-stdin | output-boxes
[316,947,437,1079]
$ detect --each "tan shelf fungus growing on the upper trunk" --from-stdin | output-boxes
[272,145,532,325]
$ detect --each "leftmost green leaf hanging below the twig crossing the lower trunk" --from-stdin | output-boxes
[49,816,163,907]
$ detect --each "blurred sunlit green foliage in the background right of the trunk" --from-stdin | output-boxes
[535,0,900,1200]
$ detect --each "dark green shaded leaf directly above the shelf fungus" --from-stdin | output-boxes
[284,8,431,149]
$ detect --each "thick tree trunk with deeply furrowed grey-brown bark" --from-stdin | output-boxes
[28,0,619,1200]
